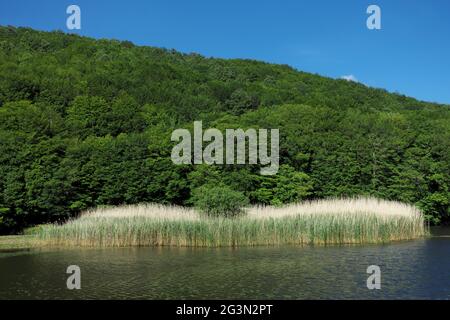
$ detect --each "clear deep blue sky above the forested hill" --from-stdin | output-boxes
[0,0,450,104]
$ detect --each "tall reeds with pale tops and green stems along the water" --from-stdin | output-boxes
[36,199,428,247]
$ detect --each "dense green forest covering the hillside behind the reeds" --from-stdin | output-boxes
[0,27,450,234]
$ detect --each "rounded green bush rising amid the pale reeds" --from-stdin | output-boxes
[192,185,249,218]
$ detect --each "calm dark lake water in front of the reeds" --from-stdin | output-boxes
[0,228,450,299]
